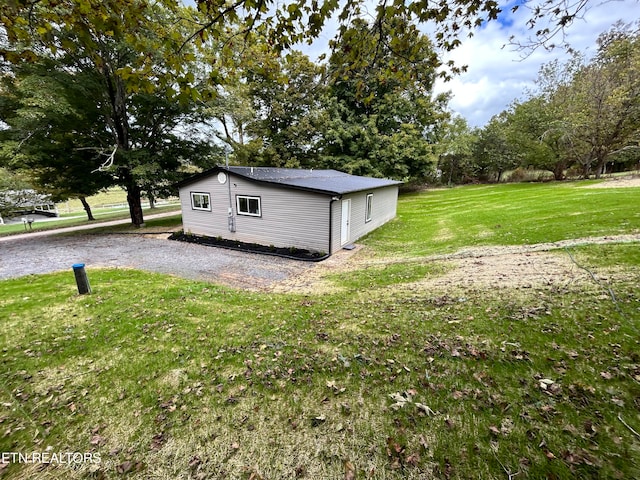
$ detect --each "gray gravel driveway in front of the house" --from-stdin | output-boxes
[0,234,314,290]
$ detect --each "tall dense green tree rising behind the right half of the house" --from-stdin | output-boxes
[321,18,448,180]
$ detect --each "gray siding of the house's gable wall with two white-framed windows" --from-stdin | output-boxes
[180,175,331,252]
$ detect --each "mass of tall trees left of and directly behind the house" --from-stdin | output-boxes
[0,0,448,225]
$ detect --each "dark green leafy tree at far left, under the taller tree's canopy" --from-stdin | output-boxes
[0,62,114,220]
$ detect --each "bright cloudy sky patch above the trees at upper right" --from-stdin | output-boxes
[436,0,640,126]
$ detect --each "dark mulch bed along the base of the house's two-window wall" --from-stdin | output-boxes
[169,231,329,262]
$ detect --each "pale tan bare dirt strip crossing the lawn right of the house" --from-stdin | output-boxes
[273,234,640,294]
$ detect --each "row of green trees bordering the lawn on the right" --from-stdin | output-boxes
[438,23,640,187]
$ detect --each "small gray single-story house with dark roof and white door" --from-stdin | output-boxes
[178,166,402,254]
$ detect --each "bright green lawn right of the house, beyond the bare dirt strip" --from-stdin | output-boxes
[367,181,640,256]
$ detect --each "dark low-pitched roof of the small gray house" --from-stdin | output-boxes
[179,166,402,195]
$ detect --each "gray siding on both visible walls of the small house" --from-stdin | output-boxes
[180,174,398,253]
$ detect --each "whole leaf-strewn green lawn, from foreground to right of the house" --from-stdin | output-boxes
[0,184,640,480]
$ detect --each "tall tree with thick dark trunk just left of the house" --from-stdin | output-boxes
[0,0,214,225]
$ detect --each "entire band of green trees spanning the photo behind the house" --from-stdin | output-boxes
[0,0,638,225]
